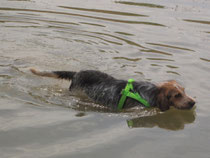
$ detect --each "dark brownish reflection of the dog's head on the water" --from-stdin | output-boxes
[127,109,195,130]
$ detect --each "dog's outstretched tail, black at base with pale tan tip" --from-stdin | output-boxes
[30,68,76,80]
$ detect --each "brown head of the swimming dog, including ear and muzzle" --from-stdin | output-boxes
[157,80,195,111]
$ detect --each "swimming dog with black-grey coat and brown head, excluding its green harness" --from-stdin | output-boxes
[30,68,195,111]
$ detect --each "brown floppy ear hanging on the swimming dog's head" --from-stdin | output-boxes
[156,88,170,111]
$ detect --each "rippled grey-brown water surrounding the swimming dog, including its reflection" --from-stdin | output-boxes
[0,0,210,158]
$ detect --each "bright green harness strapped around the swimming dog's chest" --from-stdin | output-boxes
[117,79,150,110]
